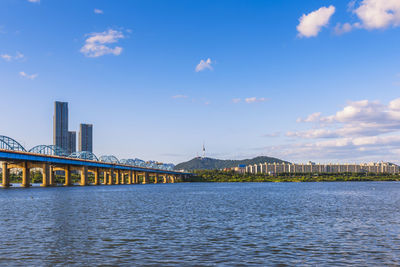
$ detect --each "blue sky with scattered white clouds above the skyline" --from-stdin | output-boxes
[0,0,400,164]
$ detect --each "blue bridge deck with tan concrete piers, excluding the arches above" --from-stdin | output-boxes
[0,149,190,188]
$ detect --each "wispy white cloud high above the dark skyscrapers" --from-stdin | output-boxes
[80,29,125,57]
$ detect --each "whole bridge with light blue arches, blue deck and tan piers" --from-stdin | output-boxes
[0,135,190,188]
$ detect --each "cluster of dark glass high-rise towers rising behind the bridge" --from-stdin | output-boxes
[53,101,93,154]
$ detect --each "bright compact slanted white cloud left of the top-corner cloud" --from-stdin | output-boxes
[297,6,335,37]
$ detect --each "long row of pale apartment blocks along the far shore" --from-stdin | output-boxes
[242,162,400,175]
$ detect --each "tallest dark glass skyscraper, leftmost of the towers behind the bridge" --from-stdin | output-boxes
[53,101,68,151]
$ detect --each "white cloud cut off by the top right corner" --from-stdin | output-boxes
[353,0,400,29]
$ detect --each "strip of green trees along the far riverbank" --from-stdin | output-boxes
[189,170,400,183]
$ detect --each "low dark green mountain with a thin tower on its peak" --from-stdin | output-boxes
[174,156,287,171]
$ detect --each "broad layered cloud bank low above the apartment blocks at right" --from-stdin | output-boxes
[288,98,400,162]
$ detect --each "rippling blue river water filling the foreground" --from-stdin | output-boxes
[0,182,400,266]
